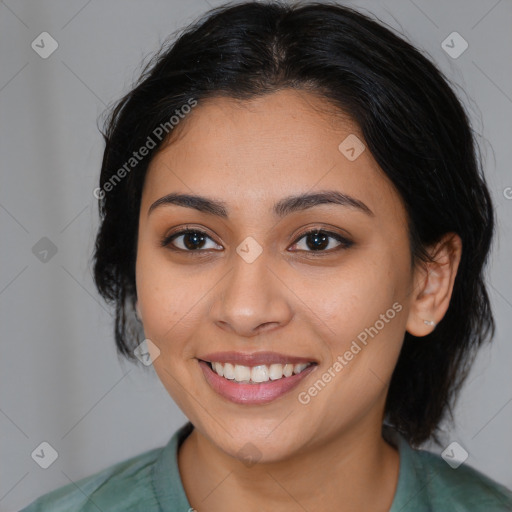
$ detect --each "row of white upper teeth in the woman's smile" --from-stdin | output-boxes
[211,362,312,383]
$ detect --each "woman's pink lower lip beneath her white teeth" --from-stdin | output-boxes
[199,361,316,405]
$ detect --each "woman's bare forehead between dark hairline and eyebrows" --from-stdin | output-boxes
[142,90,403,224]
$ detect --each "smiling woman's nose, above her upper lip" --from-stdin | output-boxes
[210,250,293,338]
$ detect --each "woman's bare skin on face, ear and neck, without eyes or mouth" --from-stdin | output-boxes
[136,90,462,512]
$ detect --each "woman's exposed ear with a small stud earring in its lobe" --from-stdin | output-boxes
[406,233,462,336]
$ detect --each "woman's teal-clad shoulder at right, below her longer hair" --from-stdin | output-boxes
[411,442,512,512]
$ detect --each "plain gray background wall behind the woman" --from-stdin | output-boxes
[0,0,512,511]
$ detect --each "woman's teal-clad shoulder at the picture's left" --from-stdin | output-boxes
[21,447,163,512]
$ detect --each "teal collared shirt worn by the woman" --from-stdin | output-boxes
[21,423,512,512]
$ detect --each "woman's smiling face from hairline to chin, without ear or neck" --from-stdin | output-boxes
[136,90,420,461]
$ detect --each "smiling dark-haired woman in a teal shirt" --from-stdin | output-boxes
[25,2,512,512]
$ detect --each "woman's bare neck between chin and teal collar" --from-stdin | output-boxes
[178,414,399,512]
